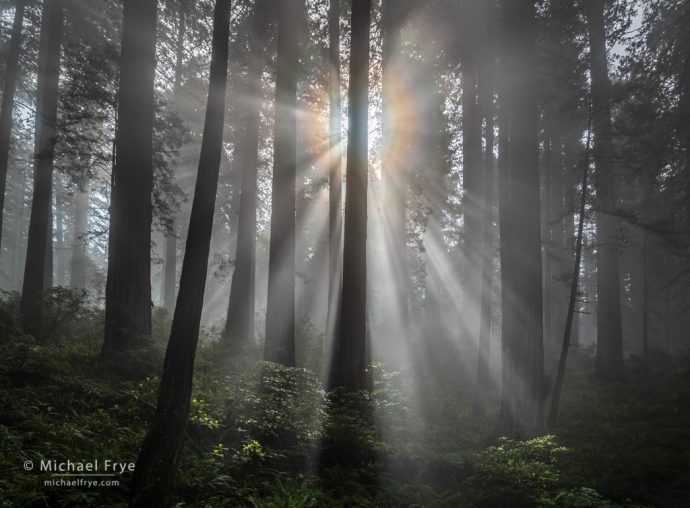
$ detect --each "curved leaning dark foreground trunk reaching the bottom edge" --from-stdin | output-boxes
[130,0,230,508]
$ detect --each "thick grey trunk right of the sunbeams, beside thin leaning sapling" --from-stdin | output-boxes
[499,0,544,437]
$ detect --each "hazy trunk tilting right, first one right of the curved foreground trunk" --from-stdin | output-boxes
[223,0,267,352]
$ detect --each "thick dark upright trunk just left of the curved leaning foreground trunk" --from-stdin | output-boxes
[102,0,158,362]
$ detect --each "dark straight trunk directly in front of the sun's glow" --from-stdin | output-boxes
[329,0,371,390]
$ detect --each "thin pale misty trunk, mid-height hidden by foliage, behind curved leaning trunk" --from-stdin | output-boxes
[161,0,187,312]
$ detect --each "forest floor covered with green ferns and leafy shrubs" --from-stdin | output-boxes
[0,300,690,508]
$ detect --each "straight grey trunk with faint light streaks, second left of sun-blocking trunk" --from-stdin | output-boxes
[264,0,302,366]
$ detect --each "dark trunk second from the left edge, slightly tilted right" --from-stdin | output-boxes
[20,0,63,334]
